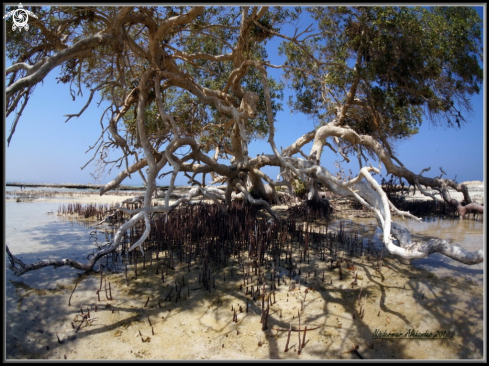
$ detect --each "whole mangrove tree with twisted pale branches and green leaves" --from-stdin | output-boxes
[6,6,483,274]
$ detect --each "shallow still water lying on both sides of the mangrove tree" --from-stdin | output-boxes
[5,193,484,288]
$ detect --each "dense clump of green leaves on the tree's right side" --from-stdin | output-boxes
[281,6,483,140]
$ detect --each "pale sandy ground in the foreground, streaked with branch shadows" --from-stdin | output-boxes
[5,189,485,360]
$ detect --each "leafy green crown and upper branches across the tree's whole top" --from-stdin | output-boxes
[6,6,483,181]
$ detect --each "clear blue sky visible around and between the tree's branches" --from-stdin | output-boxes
[4,7,486,189]
